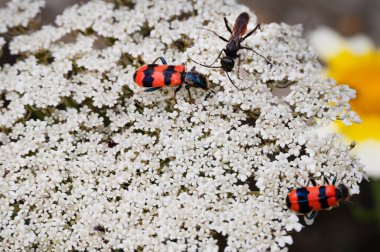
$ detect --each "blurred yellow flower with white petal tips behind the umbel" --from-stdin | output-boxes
[310,27,380,177]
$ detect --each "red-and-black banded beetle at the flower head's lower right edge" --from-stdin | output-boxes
[286,177,349,223]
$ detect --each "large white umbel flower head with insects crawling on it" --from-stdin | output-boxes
[0,0,362,251]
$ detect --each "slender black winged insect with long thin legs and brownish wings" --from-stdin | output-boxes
[190,12,271,88]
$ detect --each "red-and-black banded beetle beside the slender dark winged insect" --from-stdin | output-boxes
[133,57,215,102]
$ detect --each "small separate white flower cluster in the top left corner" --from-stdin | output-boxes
[0,0,45,34]
